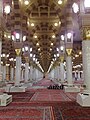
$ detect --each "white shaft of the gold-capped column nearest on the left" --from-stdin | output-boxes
[15,56,21,86]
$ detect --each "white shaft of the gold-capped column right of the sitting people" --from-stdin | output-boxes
[66,56,73,85]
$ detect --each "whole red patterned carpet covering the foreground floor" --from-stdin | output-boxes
[0,86,90,120]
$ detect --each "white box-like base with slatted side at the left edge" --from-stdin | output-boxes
[0,94,12,106]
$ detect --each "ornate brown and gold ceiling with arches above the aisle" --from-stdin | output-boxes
[1,0,82,72]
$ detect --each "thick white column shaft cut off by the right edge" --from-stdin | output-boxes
[82,40,90,90]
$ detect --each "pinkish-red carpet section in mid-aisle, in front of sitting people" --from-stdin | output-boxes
[30,90,71,102]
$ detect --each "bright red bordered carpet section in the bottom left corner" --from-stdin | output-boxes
[0,106,52,120]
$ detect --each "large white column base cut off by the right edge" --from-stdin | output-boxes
[76,91,90,107]
